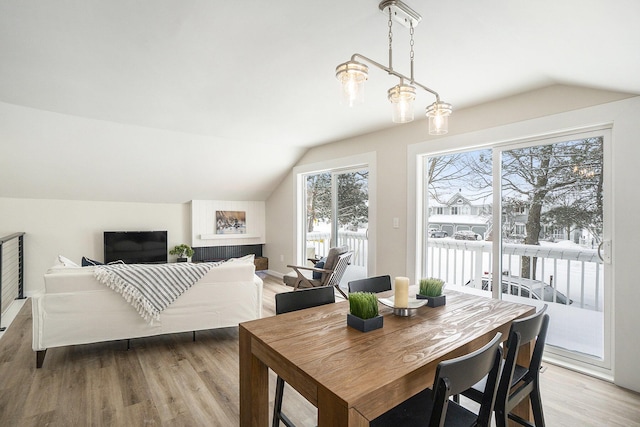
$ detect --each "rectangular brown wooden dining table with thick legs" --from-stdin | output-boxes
[239,291,535,427]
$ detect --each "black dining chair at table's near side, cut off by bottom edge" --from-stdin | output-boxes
[370,332,502,427]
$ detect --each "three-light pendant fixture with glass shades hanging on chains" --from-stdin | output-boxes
[336,0,453,135]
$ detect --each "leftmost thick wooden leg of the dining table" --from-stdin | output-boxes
[239,325,269,427]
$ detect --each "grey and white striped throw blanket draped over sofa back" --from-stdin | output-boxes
[93,262,221,323]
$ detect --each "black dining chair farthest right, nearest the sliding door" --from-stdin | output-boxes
[461,304,549,427]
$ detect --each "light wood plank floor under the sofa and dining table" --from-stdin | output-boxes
[0,277,640,427]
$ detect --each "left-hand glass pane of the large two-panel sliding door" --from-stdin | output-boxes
[422,150,493,295]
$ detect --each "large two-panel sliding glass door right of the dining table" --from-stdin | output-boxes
[422,129,611,368]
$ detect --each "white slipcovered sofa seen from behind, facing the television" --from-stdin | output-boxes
[32,258,262,368]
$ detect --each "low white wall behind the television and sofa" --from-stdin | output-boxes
[0,198,191,295]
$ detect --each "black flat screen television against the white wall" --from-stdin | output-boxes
[104,231,168,264]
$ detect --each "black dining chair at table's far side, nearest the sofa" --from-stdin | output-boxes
[272,286,336,427]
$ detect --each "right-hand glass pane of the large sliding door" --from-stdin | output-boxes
[500,137,604,358]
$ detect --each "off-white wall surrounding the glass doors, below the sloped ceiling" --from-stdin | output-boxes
[265,86,640,391]
